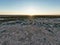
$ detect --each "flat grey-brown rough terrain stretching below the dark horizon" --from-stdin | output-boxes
[0,16,60,45]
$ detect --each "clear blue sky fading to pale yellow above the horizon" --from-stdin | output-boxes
[0,0,60,15]
